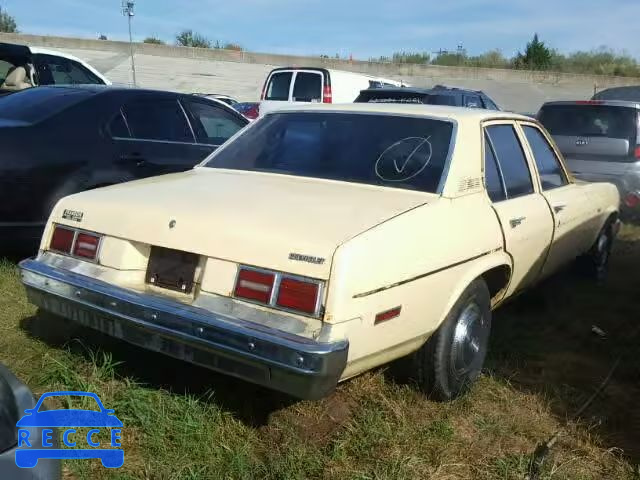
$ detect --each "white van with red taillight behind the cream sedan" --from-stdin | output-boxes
[260,67,408,114]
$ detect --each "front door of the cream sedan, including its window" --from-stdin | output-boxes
[520,122,597,275]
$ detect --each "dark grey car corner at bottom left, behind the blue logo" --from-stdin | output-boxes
[0,363,62,480]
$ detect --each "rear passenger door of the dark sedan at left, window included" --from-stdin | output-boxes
[109,95,208,178]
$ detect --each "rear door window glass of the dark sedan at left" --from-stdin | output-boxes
[123,99,195,143]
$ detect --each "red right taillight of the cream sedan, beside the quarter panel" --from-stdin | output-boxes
[234,267,323,316]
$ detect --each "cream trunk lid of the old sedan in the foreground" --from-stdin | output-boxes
[51,168,438,278]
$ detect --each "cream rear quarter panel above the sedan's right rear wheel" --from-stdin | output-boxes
[325,194,510,377]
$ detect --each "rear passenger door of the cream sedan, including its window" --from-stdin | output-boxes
[484,122,553,295]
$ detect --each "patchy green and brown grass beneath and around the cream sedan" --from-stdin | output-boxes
[0,226,640,480]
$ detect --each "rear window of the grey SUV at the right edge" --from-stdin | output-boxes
[539,105,638,144]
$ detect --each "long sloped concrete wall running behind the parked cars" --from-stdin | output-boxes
[0,33,640,112]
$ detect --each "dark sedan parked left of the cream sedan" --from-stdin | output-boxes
[0,85,248,252]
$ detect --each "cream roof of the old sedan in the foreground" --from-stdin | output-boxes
[266,103,533,122]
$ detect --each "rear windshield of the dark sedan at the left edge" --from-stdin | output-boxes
[0,87,93,123]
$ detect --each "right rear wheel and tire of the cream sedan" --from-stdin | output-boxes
[412,279,491,401]
